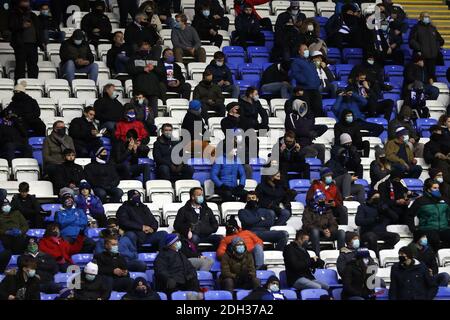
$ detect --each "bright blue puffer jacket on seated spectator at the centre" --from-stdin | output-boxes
[211,157,246,188]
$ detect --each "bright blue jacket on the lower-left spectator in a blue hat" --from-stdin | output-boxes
[55,208,88,238]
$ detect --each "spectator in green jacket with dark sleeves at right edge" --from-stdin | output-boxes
[409,179,450,252]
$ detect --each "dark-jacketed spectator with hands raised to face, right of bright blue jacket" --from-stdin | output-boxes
[272,131,310,181]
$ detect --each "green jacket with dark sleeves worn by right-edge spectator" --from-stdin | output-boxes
[410,192,450,231]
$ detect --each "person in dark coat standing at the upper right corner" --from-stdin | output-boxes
[409,12,444,85]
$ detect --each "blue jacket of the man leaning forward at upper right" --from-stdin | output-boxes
[289,57,320,90]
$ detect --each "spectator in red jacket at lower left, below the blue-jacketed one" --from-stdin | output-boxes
[39,223,85,272]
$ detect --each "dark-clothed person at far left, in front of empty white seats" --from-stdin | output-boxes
[11,182,49,229]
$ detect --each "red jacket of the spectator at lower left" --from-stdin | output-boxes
[39,235,85,264]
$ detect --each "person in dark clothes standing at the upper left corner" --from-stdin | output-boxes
[8,0,45,81]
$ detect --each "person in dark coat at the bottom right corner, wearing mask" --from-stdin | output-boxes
[389,247,438,301]
